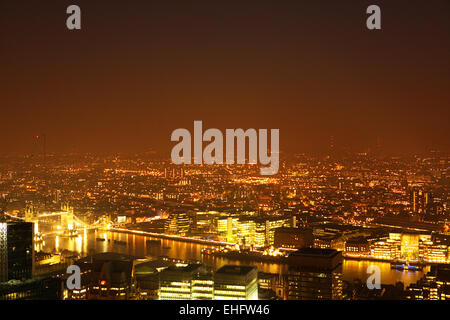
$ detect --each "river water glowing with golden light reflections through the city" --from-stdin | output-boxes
[36,231,428,285]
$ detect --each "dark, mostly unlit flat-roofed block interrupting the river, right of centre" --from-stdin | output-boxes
[288,248,342,300]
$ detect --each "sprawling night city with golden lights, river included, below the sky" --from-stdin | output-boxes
[0,145,450,300]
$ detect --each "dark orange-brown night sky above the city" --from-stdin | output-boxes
[0,0,450,156]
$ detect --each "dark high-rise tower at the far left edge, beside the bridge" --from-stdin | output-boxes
[0,221,34,282]
